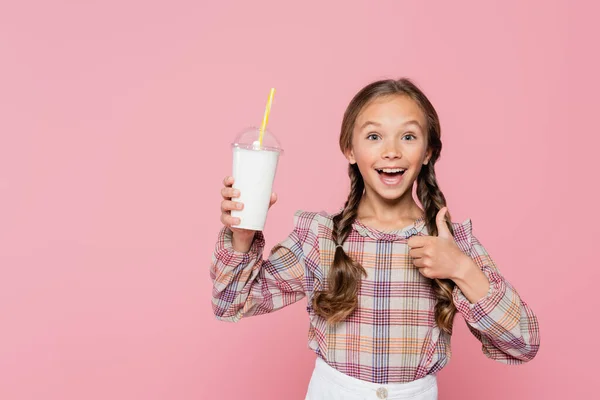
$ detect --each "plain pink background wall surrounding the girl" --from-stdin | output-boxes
[0,0,600,400]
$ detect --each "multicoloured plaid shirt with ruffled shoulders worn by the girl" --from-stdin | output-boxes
[210,211,539,384]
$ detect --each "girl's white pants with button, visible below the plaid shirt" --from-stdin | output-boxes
[305,357,437,400]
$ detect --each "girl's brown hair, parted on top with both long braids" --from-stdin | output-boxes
[312,78,456,333]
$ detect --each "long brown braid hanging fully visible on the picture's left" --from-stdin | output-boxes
[313,164,366,324]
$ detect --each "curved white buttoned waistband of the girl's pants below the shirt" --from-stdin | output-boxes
[314,356,437,398]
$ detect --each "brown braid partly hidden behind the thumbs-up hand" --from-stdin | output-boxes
[417,159,456,334]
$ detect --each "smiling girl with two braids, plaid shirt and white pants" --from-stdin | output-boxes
[210,79,539,400]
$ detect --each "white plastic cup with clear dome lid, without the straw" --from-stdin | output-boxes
[231,127,283,231]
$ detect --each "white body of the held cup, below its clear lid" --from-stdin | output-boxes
[231,147,279,231]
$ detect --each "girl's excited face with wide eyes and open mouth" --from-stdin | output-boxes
[346,95,431,200]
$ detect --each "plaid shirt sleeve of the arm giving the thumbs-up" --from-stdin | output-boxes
[452,226,540,364]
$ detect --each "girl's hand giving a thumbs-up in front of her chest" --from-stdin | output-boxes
[407,207,472,279]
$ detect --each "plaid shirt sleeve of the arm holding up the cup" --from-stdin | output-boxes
[210,211,318,322]
